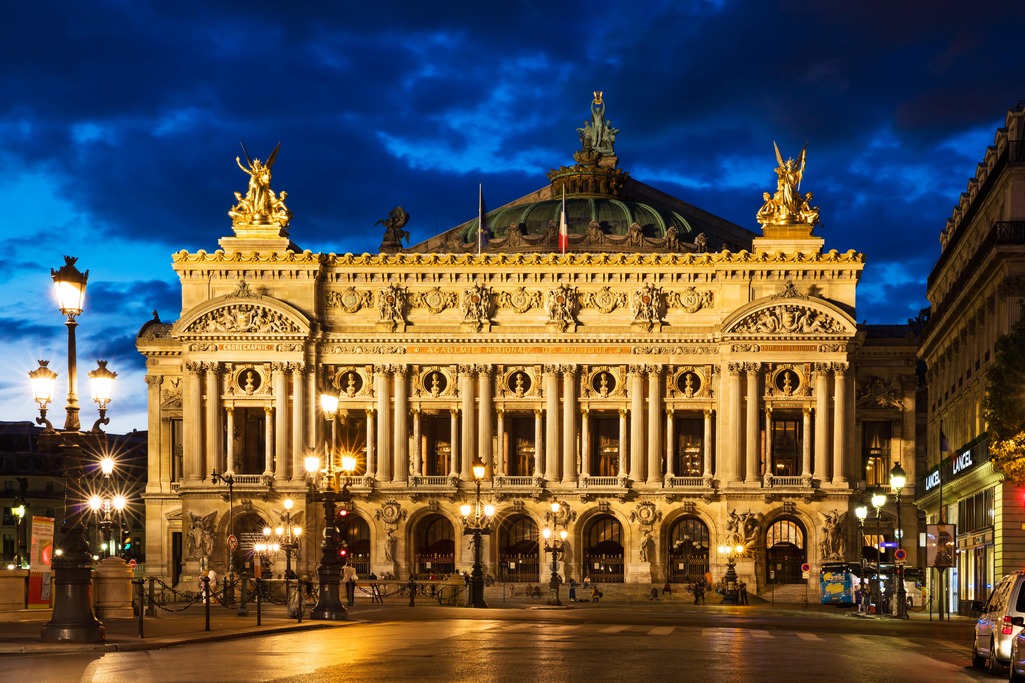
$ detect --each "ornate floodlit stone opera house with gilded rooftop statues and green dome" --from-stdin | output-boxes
[138,93,915,599]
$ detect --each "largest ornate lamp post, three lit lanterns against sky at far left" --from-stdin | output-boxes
[29,256,117,643]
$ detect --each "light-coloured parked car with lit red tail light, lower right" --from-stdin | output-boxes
[972,570,1025,674]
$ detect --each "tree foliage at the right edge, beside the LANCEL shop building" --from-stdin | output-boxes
[986,319,1025,485]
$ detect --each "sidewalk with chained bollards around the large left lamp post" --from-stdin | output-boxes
[0,605,350,654]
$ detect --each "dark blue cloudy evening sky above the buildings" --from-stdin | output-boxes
[0,0,1025,432]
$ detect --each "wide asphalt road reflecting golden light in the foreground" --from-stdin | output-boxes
[2,605,984,683]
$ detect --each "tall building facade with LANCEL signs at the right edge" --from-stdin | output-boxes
[918,102,1025,611]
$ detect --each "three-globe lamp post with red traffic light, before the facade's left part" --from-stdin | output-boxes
[304,394,357,620]
